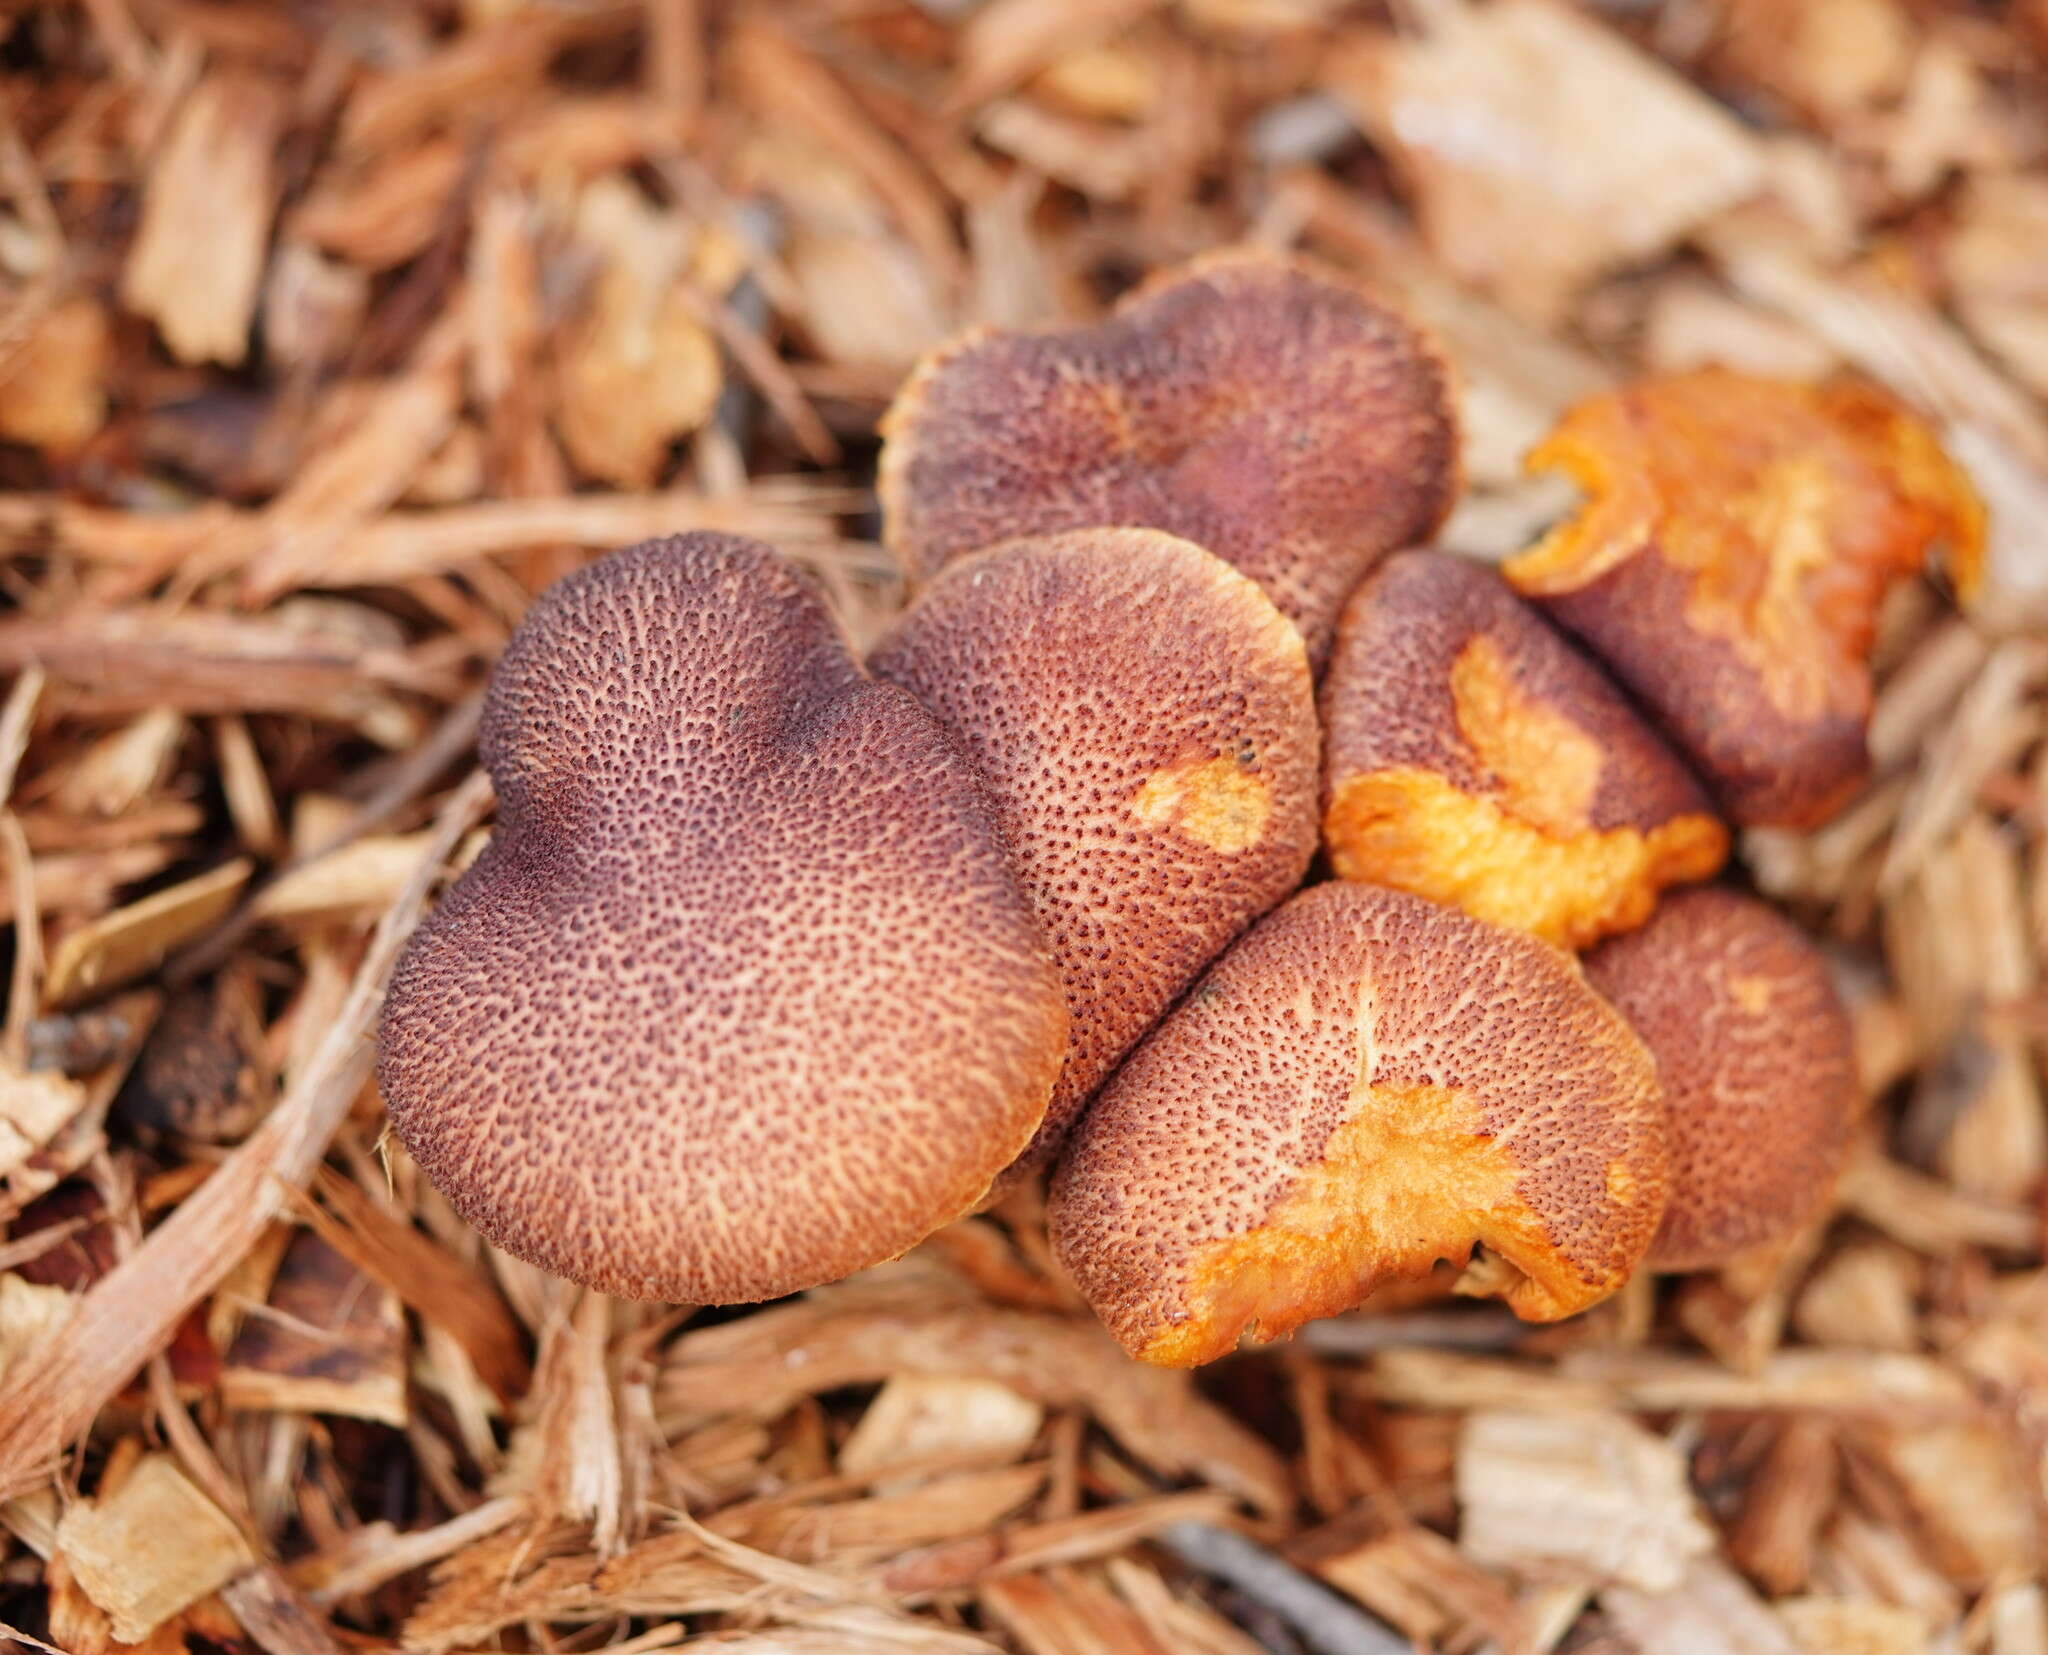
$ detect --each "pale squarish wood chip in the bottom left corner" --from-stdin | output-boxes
[57,1454,256,1643]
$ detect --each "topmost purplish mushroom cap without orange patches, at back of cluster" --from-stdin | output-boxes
[879,252,1458,668]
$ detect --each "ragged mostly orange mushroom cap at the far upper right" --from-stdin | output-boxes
[1505,369,1985,828]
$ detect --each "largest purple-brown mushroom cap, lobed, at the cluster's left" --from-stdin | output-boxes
[379,535,1065,1303]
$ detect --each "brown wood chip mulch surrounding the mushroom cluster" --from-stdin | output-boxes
[0,0,2048,1655]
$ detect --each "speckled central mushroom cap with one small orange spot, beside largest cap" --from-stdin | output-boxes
[872,528,1319,1172]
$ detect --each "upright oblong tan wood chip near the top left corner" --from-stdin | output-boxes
[121,70,285,367]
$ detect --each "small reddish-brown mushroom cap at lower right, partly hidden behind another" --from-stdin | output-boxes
[1585,889,1862,1270]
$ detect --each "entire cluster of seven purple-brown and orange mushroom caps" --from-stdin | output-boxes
[379,254,1982,1364]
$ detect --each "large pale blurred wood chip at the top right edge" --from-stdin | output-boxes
[1331,0,1763,320]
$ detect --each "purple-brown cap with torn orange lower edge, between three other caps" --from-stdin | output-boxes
[1323,551,1729,948]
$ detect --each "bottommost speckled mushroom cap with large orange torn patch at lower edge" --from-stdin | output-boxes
[1051,883,1665,1366]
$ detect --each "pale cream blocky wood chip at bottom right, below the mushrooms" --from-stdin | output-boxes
[1458,1411,1714,1592]
